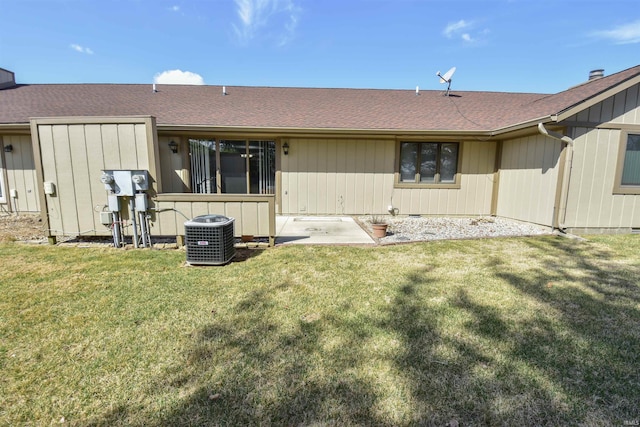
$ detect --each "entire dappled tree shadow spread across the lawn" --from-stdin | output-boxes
[87,238,640,425]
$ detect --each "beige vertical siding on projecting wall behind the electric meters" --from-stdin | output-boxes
[35,119,153,236]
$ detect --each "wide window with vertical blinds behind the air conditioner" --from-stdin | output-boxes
[189,139,276,194]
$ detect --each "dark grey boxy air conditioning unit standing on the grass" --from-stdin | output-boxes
[184,215,236,265]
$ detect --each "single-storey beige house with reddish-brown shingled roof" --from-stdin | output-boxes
[0,66,640,242]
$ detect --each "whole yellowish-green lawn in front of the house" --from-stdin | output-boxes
[0,236,640,426]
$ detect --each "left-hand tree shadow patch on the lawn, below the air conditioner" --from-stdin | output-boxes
[141,283,381,426]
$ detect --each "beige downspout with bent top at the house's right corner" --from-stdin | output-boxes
[538,122,573,232]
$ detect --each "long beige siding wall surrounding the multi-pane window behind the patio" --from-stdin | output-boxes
[281,138,496,215]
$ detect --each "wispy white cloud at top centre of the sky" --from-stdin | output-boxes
[233,0,300,45]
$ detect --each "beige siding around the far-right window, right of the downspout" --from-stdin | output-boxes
[561,85,640,231]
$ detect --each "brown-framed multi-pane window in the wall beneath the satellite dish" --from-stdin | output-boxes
[398,142,460,187]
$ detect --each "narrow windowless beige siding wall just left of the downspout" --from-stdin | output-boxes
[497,135,562,226]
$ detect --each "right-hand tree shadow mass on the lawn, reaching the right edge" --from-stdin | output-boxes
[385,238,640,425]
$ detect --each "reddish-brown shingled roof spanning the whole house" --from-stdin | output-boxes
[0,66,640,132]
